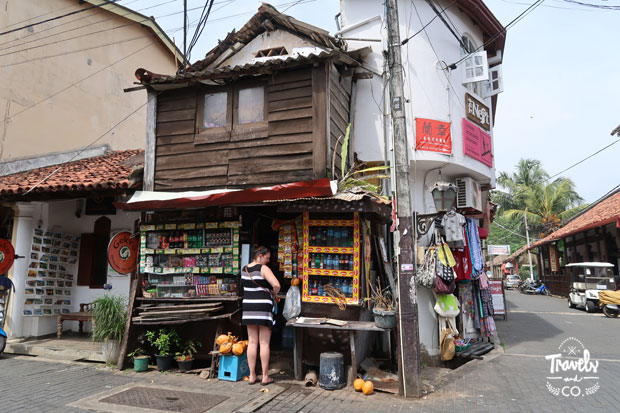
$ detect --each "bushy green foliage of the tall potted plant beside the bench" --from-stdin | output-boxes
[91,294,127,341]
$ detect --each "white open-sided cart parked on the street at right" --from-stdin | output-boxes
[566,262,616,313]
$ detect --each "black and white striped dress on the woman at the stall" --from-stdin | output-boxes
[241,264,276,327]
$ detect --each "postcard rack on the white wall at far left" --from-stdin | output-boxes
[23,228,80,317]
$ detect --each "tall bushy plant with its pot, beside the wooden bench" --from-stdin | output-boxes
[91,294,127,364]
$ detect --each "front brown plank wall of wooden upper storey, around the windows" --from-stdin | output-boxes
[155,68,326,191]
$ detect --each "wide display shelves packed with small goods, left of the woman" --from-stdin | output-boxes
[140,221,239,298]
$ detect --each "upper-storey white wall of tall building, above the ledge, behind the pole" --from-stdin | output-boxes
[341,0,495,186]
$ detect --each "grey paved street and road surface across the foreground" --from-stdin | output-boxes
[0,291,620,413]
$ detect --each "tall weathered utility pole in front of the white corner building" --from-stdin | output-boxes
[387,0,421,397]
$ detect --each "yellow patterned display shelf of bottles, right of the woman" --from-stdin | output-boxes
[302,212,360,305]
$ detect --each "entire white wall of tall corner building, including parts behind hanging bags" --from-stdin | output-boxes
[340,0,502,355]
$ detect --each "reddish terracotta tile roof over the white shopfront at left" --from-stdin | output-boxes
[0,149,144,198]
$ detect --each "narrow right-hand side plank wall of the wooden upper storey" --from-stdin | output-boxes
[328,65,352,179]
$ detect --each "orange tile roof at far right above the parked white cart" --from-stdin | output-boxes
[532,191,620,248]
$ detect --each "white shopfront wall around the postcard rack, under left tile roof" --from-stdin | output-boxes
[9,200,140,337]
